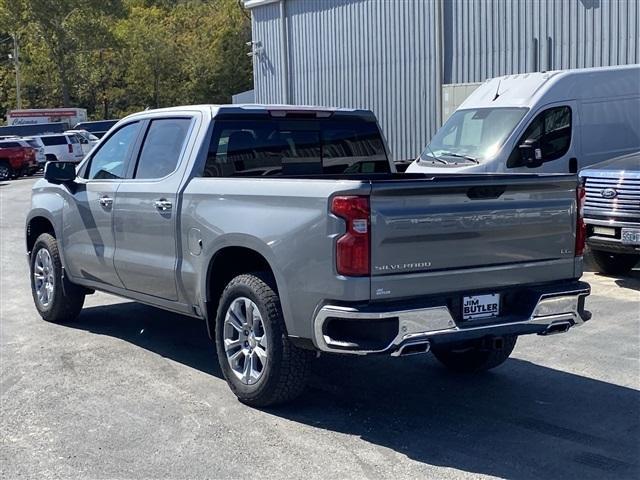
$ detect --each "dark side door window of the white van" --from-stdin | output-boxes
[509,107,571,165]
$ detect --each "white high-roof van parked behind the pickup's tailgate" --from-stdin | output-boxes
[407,65,640,173]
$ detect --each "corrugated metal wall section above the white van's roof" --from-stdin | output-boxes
[443,0,640,83]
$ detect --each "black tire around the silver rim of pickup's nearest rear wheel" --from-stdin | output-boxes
[215,272,314,407]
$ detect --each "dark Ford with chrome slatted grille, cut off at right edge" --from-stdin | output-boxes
[580,152,640,275]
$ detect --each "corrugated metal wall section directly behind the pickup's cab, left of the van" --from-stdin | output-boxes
[252,0,439,159]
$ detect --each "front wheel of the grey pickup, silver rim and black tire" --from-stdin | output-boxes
[31,233,85,323]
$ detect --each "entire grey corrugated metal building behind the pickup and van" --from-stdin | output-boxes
[245,0,640,160]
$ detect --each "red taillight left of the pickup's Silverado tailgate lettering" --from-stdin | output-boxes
[331,196,371,277]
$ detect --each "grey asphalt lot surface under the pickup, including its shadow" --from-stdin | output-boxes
[0,179,640,480]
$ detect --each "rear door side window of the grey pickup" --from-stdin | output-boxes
[135,118,191,178]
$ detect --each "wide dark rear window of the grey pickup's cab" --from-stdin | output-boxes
[204,118,390,177]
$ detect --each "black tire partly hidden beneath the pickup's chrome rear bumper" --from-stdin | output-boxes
[432,335,518,373]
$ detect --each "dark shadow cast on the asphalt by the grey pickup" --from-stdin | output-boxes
[70,303,640,480]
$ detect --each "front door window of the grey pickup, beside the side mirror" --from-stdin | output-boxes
[86,122,139,179]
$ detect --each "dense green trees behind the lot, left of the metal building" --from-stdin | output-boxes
[0,0,252,118]
